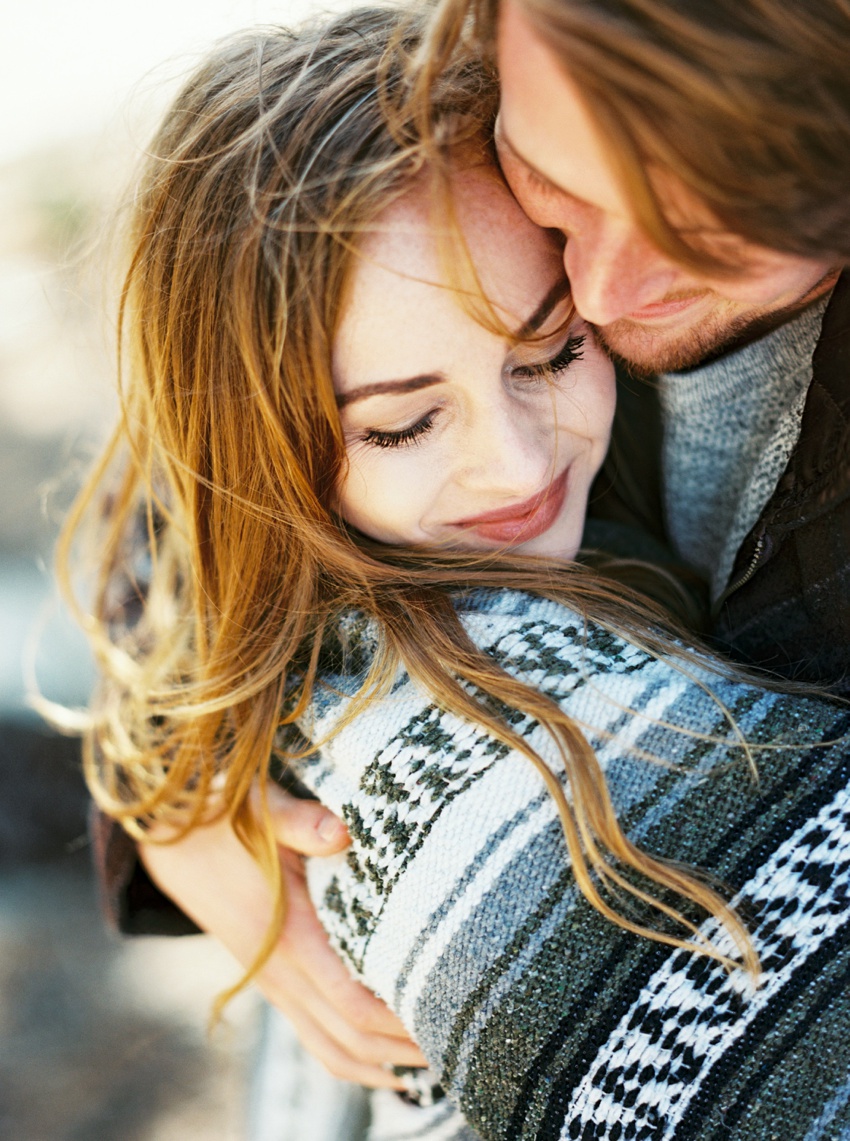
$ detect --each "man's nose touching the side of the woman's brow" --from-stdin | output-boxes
[564,217,680,326]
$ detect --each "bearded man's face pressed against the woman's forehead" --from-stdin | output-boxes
[496,0,837,372]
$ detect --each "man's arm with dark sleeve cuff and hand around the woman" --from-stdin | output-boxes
[89,502,424,1089]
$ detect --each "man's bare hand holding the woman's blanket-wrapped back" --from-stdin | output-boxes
[139,786,427,1089]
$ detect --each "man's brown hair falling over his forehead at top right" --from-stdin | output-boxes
[417,0,850,266]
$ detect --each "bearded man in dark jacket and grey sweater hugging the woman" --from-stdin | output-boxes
[94,0,850,1104]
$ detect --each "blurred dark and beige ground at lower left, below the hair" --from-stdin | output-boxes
[0,723,254,1141]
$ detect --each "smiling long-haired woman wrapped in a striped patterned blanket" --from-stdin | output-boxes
[64,10,844,1136]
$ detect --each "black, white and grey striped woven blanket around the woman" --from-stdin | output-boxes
[280,591,850,1141]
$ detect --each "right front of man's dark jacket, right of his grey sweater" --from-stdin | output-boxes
[714,270,850,696]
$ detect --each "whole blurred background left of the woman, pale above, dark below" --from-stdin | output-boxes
[0,0,351,1141]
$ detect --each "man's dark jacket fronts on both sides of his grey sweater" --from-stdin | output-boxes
[590,270,850,696]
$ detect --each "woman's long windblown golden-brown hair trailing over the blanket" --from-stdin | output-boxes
[59,8,756,970]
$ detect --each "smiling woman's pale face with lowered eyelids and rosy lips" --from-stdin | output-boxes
[333,167,615,559]
